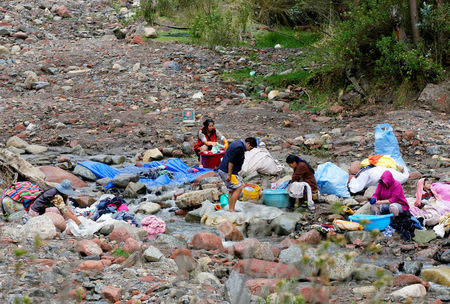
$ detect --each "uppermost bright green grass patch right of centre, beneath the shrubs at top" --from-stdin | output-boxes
[255,28,322,49]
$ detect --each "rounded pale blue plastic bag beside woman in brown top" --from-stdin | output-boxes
[314,162,350,197]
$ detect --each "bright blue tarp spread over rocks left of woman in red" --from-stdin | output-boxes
[78,158,212,188]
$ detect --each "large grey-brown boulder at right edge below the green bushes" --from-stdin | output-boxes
[418,80,450,114]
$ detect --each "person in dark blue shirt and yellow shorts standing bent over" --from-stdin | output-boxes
[217,137,257,212]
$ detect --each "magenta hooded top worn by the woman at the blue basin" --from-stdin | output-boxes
[373,171,409,211]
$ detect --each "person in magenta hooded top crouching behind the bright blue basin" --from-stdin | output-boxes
[370,171,409,216]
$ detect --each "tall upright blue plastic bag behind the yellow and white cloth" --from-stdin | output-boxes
[375,123,407,170]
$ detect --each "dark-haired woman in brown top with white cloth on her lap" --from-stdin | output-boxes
[286,155,319,210]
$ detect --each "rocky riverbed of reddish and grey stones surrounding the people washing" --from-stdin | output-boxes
[0,0,450,303]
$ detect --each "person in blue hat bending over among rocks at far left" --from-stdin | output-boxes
[28,179,81,226]
